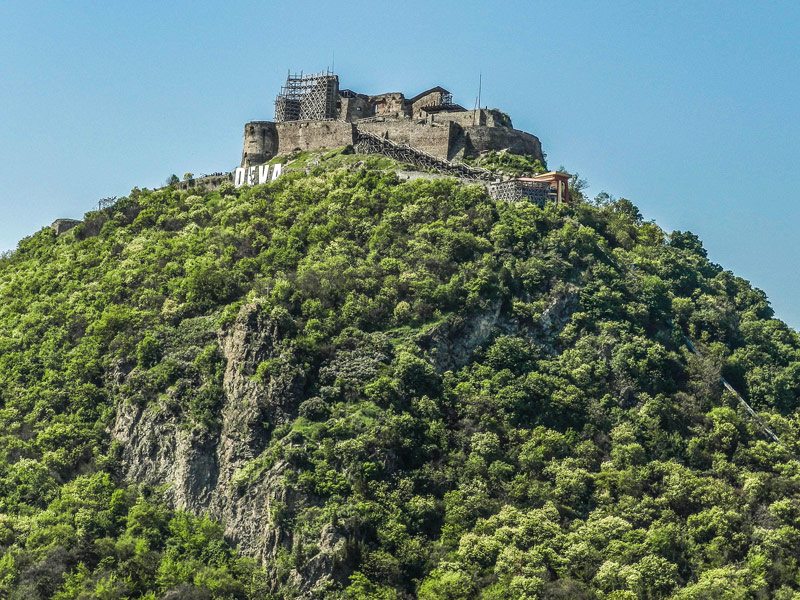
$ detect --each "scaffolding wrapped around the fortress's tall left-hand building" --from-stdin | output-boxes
[275,71,339,123]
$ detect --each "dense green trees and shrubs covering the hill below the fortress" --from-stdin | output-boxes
[0,154,800,600]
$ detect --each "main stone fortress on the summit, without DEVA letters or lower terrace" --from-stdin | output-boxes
[241,72,543,168]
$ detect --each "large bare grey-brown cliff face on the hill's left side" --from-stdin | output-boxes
[112,305,344,591]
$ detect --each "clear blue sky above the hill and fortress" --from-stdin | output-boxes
[0,0,800,328]
